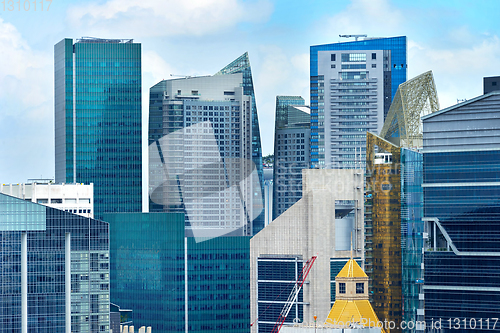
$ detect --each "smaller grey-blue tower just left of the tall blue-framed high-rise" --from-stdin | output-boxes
[273,96,311,220]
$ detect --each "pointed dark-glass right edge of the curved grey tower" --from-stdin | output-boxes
[215,52,265,235]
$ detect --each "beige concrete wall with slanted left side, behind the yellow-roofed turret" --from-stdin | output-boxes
[250,169,364,332]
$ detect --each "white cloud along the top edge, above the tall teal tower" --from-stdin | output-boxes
[67,0,273,38]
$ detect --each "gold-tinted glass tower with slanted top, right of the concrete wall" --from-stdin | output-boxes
[365,133,402,333]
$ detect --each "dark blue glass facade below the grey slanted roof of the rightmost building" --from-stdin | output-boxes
[424,150,500,332]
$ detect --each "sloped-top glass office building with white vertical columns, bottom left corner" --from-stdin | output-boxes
[0,193,110,333]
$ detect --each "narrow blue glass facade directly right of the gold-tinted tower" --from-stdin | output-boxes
[401,148,424,332]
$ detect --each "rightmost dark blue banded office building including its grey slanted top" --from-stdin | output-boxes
[422,91,500,332]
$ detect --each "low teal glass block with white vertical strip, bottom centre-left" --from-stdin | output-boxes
[105,213,250,333]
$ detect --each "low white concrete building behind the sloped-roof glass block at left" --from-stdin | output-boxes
[0,182,94,218]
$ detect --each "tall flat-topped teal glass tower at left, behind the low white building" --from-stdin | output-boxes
[54,38,142,218]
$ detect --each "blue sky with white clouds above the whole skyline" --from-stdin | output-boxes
[0,0,500,183]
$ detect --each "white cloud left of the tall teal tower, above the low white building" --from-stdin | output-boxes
[0,19,54,183]
